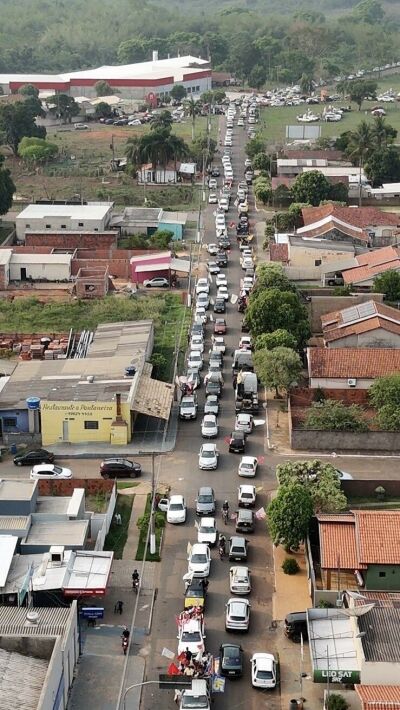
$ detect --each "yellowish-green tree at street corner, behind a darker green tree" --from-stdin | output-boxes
[276,459,347,513]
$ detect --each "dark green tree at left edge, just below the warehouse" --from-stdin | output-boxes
[0,99,46,155]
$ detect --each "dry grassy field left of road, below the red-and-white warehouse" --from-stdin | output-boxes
[7,116,218,210]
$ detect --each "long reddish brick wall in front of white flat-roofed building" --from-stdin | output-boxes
[25,231,118,249]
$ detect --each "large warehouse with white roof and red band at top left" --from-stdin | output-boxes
[0,52,211,99]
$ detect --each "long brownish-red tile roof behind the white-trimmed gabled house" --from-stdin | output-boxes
[302,203,400,229]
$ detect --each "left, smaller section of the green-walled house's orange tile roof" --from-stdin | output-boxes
[317,515,358,570]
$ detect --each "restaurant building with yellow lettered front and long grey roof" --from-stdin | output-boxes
[0,321,173,446]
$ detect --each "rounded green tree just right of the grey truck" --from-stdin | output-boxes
[255,346,301,397]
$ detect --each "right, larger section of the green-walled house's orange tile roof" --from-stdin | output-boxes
[352,510,400,565]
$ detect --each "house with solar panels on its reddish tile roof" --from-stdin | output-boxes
[321,300,400,348]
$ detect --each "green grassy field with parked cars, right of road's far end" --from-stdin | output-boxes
[257,98,400,145]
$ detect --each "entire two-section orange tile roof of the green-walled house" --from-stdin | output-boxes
[317,510,400,570]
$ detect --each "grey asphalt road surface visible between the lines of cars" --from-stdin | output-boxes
[143,107,279,710]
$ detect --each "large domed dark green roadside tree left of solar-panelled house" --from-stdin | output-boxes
[246,288,310,347]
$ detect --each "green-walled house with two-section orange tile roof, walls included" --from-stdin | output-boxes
[317,510,400,591]
